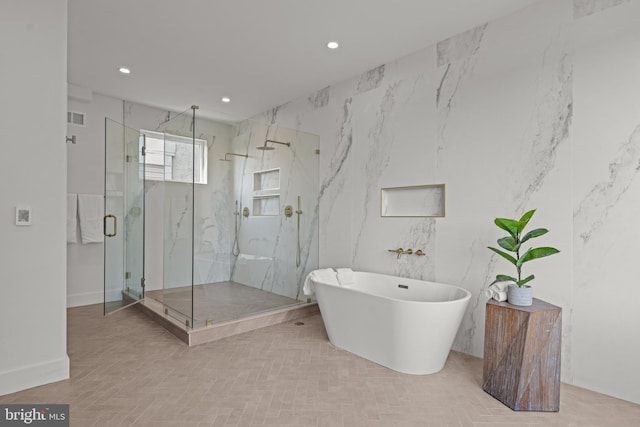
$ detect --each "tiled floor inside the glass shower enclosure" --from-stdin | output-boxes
[145,282,302,326]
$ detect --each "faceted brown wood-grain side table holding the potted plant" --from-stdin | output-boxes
[482,298,562,412]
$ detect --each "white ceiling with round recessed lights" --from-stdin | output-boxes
[68,0,538,120]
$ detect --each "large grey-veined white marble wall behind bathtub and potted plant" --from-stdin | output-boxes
[255,0,640,403]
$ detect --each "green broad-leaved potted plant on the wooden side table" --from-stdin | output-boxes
[489,209,560,306]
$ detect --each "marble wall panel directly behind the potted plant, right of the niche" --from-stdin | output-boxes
[436,2,572,356]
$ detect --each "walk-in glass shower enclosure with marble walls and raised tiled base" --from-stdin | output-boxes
[105,108,319,345]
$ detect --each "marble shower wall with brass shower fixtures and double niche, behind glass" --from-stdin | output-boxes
[231,122,321,298]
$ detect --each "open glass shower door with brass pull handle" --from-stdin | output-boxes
[103,118,144,314]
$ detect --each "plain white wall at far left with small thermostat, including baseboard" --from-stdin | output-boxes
[0,0,69,394]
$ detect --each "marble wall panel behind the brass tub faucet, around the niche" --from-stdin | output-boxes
[345,69,436,280]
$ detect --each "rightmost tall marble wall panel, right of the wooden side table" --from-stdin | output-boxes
[570,21,640,402]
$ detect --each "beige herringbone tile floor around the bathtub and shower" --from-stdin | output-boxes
[0,305,640,427]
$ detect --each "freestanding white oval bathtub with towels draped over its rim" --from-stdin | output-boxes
[313,272,471,375]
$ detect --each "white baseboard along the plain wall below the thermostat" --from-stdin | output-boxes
[0,354,69,396]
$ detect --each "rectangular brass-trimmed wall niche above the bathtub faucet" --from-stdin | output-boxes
[380,184,445,217]
